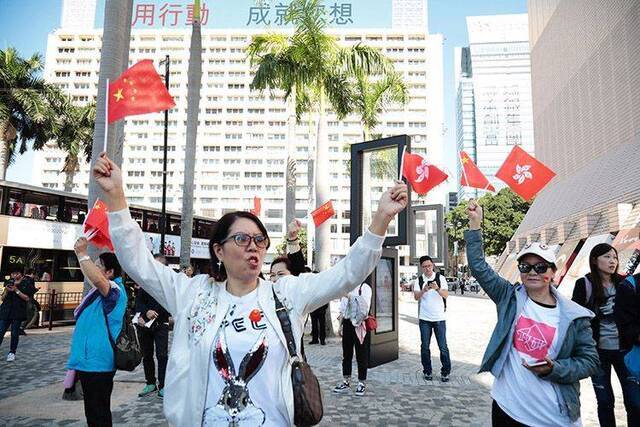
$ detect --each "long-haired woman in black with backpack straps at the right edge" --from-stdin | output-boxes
[572,243,640,427]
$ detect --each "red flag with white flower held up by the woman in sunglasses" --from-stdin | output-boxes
[496,145,556,200]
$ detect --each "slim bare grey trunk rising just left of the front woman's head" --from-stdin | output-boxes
[180,16,202,266]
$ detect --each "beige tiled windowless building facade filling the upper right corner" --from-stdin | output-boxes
[501,0,640,293]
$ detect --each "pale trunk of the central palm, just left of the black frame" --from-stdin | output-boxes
[315,89,331,271]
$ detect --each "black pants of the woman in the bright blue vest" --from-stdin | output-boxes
[77,371,115,427]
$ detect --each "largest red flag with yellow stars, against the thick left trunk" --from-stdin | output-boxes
[108,59,176,123]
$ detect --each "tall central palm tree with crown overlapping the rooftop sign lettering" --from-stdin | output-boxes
[248,0,389,270]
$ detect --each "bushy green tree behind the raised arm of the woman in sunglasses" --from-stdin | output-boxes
[446,188,531,255]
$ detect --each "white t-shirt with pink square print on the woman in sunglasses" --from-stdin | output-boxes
[491,299,582,427]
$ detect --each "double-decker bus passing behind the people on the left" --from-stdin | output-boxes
[0,180,216,328]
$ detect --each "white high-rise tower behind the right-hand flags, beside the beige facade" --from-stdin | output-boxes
[456,14,534,198]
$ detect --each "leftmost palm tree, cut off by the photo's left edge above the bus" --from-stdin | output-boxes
[0,48,55,179]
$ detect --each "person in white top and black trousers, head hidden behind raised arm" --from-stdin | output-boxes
[333,283,373,396]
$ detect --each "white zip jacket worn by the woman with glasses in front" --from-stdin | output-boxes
[109,209,384,427]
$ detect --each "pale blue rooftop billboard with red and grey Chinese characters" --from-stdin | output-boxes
[95,0,393,30]
